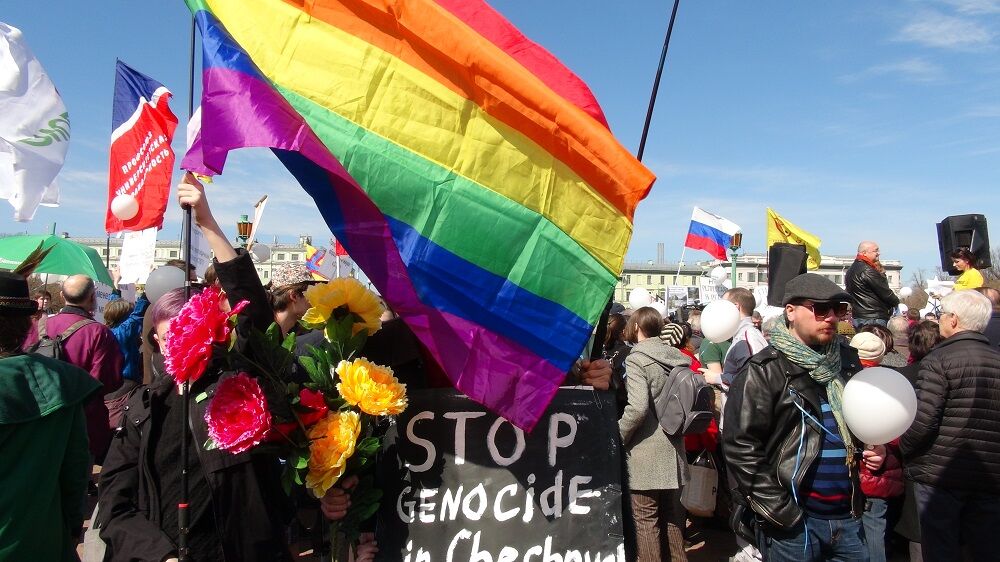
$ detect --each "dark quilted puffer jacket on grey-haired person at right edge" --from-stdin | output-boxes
[900,332,1000,494]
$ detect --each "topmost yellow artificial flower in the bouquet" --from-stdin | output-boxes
[302,277,384,335]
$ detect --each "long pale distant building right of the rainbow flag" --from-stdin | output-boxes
[615,254,903,303]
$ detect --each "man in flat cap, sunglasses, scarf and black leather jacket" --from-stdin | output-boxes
[723,273,884,562]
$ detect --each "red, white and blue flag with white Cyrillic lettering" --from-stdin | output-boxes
[104,61,177,234]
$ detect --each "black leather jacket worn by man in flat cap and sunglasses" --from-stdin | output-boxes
[722,342,865,530]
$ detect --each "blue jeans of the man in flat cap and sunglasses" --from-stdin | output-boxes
[757,515,868,562]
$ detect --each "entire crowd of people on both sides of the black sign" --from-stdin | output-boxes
[0,170,1000,562]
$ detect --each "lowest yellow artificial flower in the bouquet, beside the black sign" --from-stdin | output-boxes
[306,411,361,498]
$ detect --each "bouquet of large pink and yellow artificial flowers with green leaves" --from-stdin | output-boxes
[164,278,407,556]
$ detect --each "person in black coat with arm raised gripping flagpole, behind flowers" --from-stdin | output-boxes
[97,178,293,562]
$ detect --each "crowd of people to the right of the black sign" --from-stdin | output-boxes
[604,242,1000,562]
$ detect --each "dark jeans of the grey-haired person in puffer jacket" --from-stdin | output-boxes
[913,482,1000,562]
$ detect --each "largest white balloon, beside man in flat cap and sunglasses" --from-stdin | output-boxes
[844,367,917,445]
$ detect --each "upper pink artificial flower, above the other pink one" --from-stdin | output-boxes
[162,286,249,384]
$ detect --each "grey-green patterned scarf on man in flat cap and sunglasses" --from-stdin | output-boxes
[771,316,854,456]
